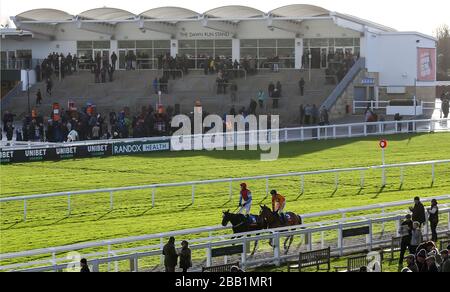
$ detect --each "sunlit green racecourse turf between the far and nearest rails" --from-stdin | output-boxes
[0,134,450,262]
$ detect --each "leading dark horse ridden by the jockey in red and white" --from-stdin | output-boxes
[222,210,267,255]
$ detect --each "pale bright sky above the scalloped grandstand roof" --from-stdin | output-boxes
[0,0,450,35]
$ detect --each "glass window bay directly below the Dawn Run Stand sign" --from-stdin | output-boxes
[178,39,233,69]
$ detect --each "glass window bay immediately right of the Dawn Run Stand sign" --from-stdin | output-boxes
[241,39,295,68]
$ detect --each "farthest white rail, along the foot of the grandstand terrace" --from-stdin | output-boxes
[0,118,450,151]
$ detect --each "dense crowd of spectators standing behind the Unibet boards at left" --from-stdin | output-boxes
[3,104,174,142]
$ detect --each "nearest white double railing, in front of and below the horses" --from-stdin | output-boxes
[0,195,450,271]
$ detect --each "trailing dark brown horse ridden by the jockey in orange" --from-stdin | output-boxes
[260,206,302,254]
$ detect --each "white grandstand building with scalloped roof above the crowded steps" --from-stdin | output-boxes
[1,4,436,121]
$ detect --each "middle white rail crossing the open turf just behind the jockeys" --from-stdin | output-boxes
[0,160,450,222]
